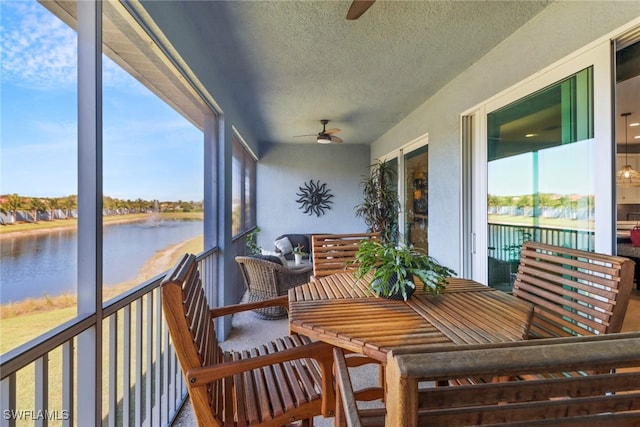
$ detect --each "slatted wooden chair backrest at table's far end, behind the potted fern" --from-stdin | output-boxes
[311,233,380,277]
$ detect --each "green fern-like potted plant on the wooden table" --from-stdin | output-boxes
[353,240,456,301]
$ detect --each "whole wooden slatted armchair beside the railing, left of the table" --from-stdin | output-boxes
[161,254,335,426]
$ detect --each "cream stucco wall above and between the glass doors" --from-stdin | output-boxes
[371,1,640,278]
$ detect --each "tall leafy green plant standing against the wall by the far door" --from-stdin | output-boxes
[355,160,400,242]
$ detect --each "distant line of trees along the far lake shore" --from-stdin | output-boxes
[0,193,203,222]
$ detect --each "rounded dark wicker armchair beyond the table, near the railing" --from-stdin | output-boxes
[235,256,313,320]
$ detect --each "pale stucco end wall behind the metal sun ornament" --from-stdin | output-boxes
[257,144,370,250]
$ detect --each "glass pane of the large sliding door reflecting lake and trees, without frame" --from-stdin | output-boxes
[487,67,595,291]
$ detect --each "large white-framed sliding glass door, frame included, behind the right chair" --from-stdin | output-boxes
[463,43,614,291]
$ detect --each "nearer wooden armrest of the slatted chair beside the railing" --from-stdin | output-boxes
[185,341,333,387]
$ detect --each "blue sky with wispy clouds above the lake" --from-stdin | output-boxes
[0,0,203,201]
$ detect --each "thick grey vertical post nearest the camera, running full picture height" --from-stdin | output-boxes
[76,0,102,425]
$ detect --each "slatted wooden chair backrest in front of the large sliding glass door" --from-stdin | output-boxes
[513,242,634,337]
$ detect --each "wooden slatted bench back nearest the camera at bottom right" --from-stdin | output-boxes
[336,332,640,427]
